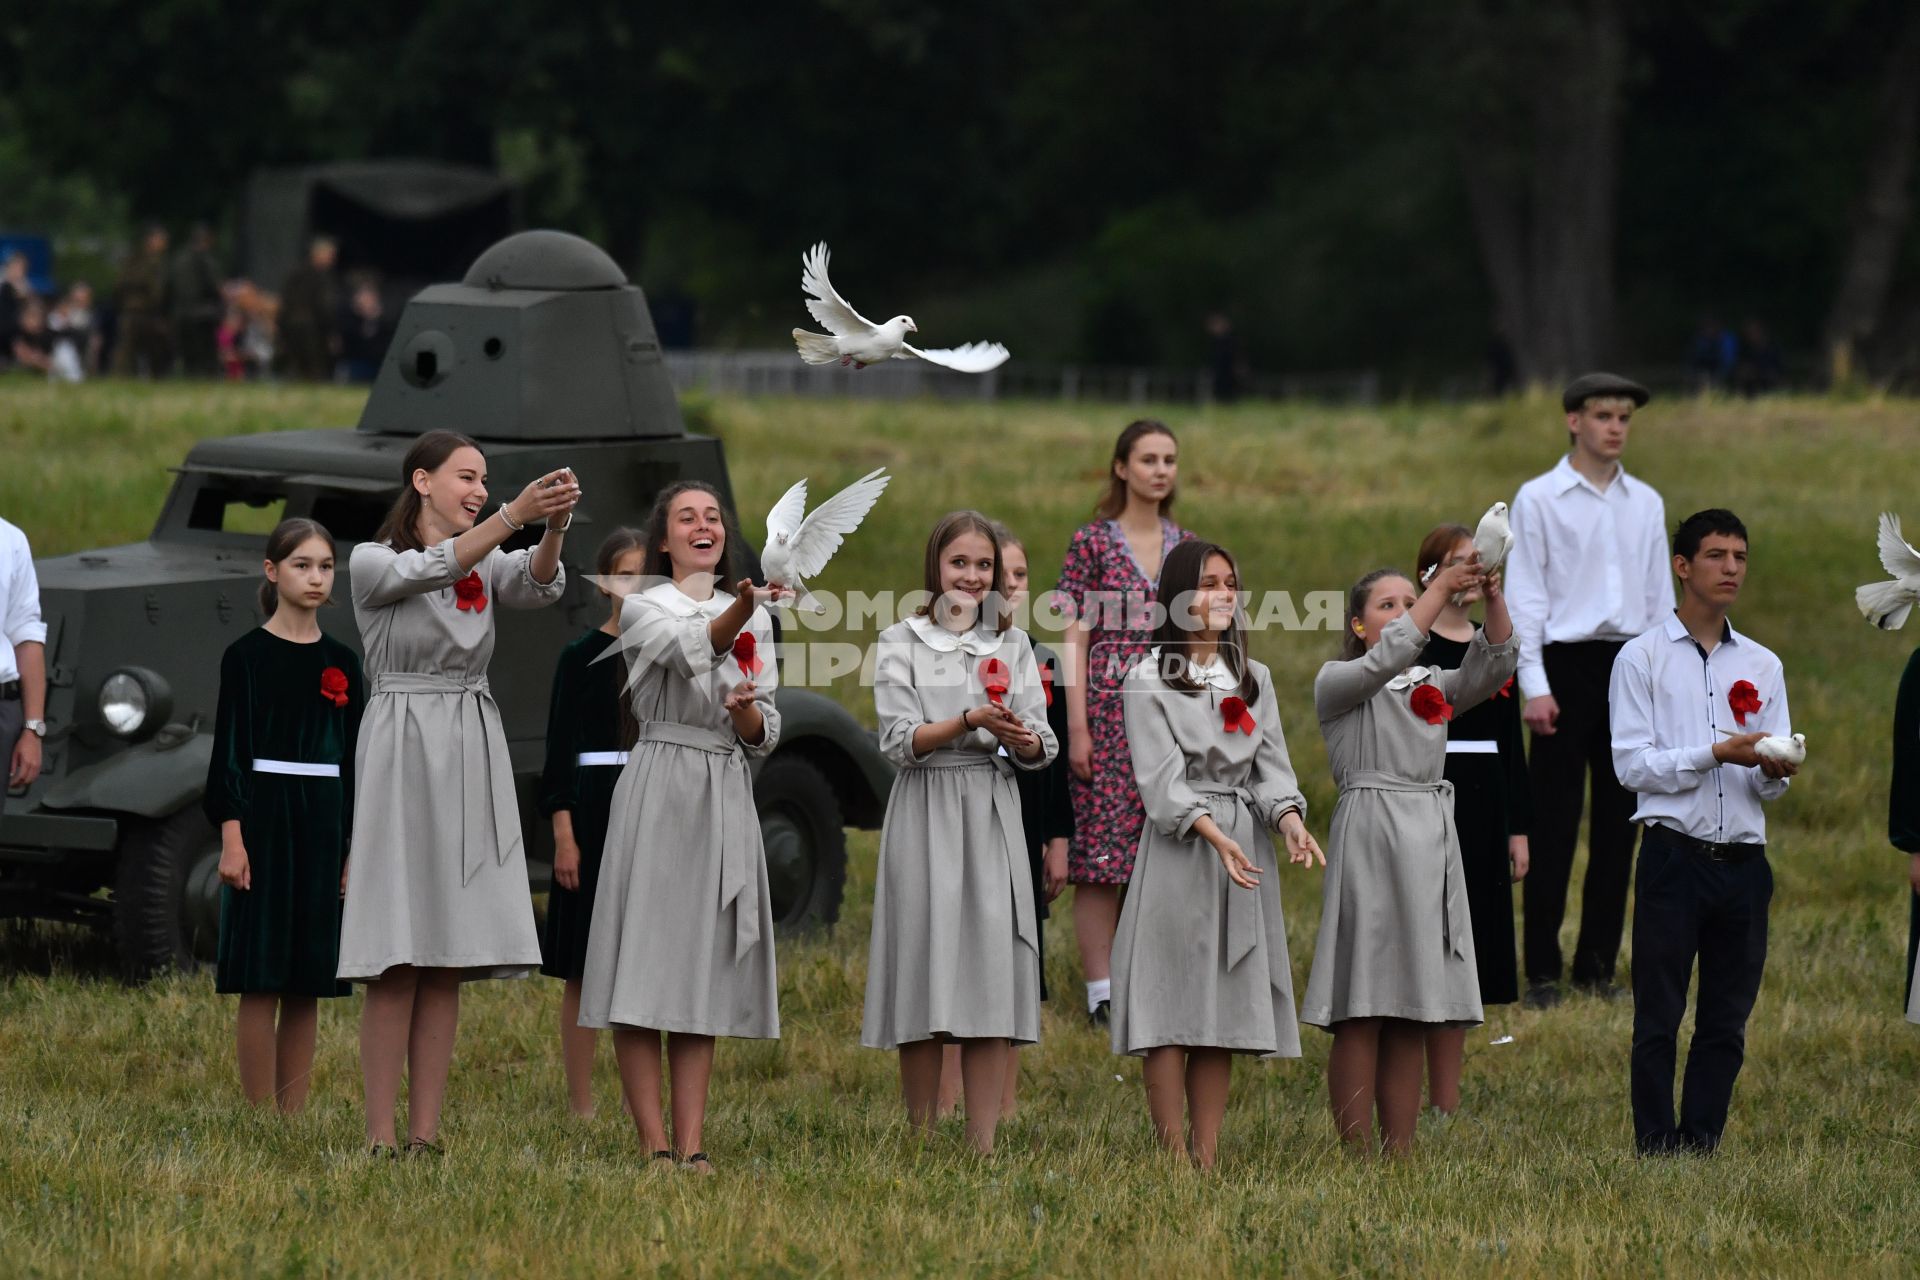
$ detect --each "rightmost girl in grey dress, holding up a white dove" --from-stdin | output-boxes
[1300,557,1519,1153]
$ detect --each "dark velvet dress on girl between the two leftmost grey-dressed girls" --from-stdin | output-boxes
[540,629,626,983]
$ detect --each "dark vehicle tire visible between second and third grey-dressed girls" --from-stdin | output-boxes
[753,750,847,933]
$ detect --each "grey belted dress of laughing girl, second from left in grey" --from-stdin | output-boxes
[580,583,780,1040]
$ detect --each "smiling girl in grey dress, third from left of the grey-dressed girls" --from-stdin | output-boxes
[860,510,1058,1151]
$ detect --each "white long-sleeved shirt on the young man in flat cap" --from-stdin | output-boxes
[1505,455,1674,699]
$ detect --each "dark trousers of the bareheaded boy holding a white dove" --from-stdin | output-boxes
[1632,825,1774,1153]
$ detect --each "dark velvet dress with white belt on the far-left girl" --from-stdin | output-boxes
[204,628,367,996]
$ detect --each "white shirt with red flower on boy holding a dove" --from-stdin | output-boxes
[1607,614,1793,844]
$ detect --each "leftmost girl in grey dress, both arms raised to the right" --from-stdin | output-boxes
[340,432,580,1155]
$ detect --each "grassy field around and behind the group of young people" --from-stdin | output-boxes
[0,382,1920,1276]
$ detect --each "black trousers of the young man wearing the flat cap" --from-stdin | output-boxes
[1521,641,1634,983]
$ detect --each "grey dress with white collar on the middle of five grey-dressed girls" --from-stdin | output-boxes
[860,618,1058,1050]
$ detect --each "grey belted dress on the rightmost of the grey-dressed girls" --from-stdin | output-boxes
[1300,614,1519,1027]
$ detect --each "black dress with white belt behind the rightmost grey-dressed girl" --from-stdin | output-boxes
[1421,633,1534,1004]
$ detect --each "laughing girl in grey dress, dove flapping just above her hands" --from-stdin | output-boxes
[580,482,791,1173]
